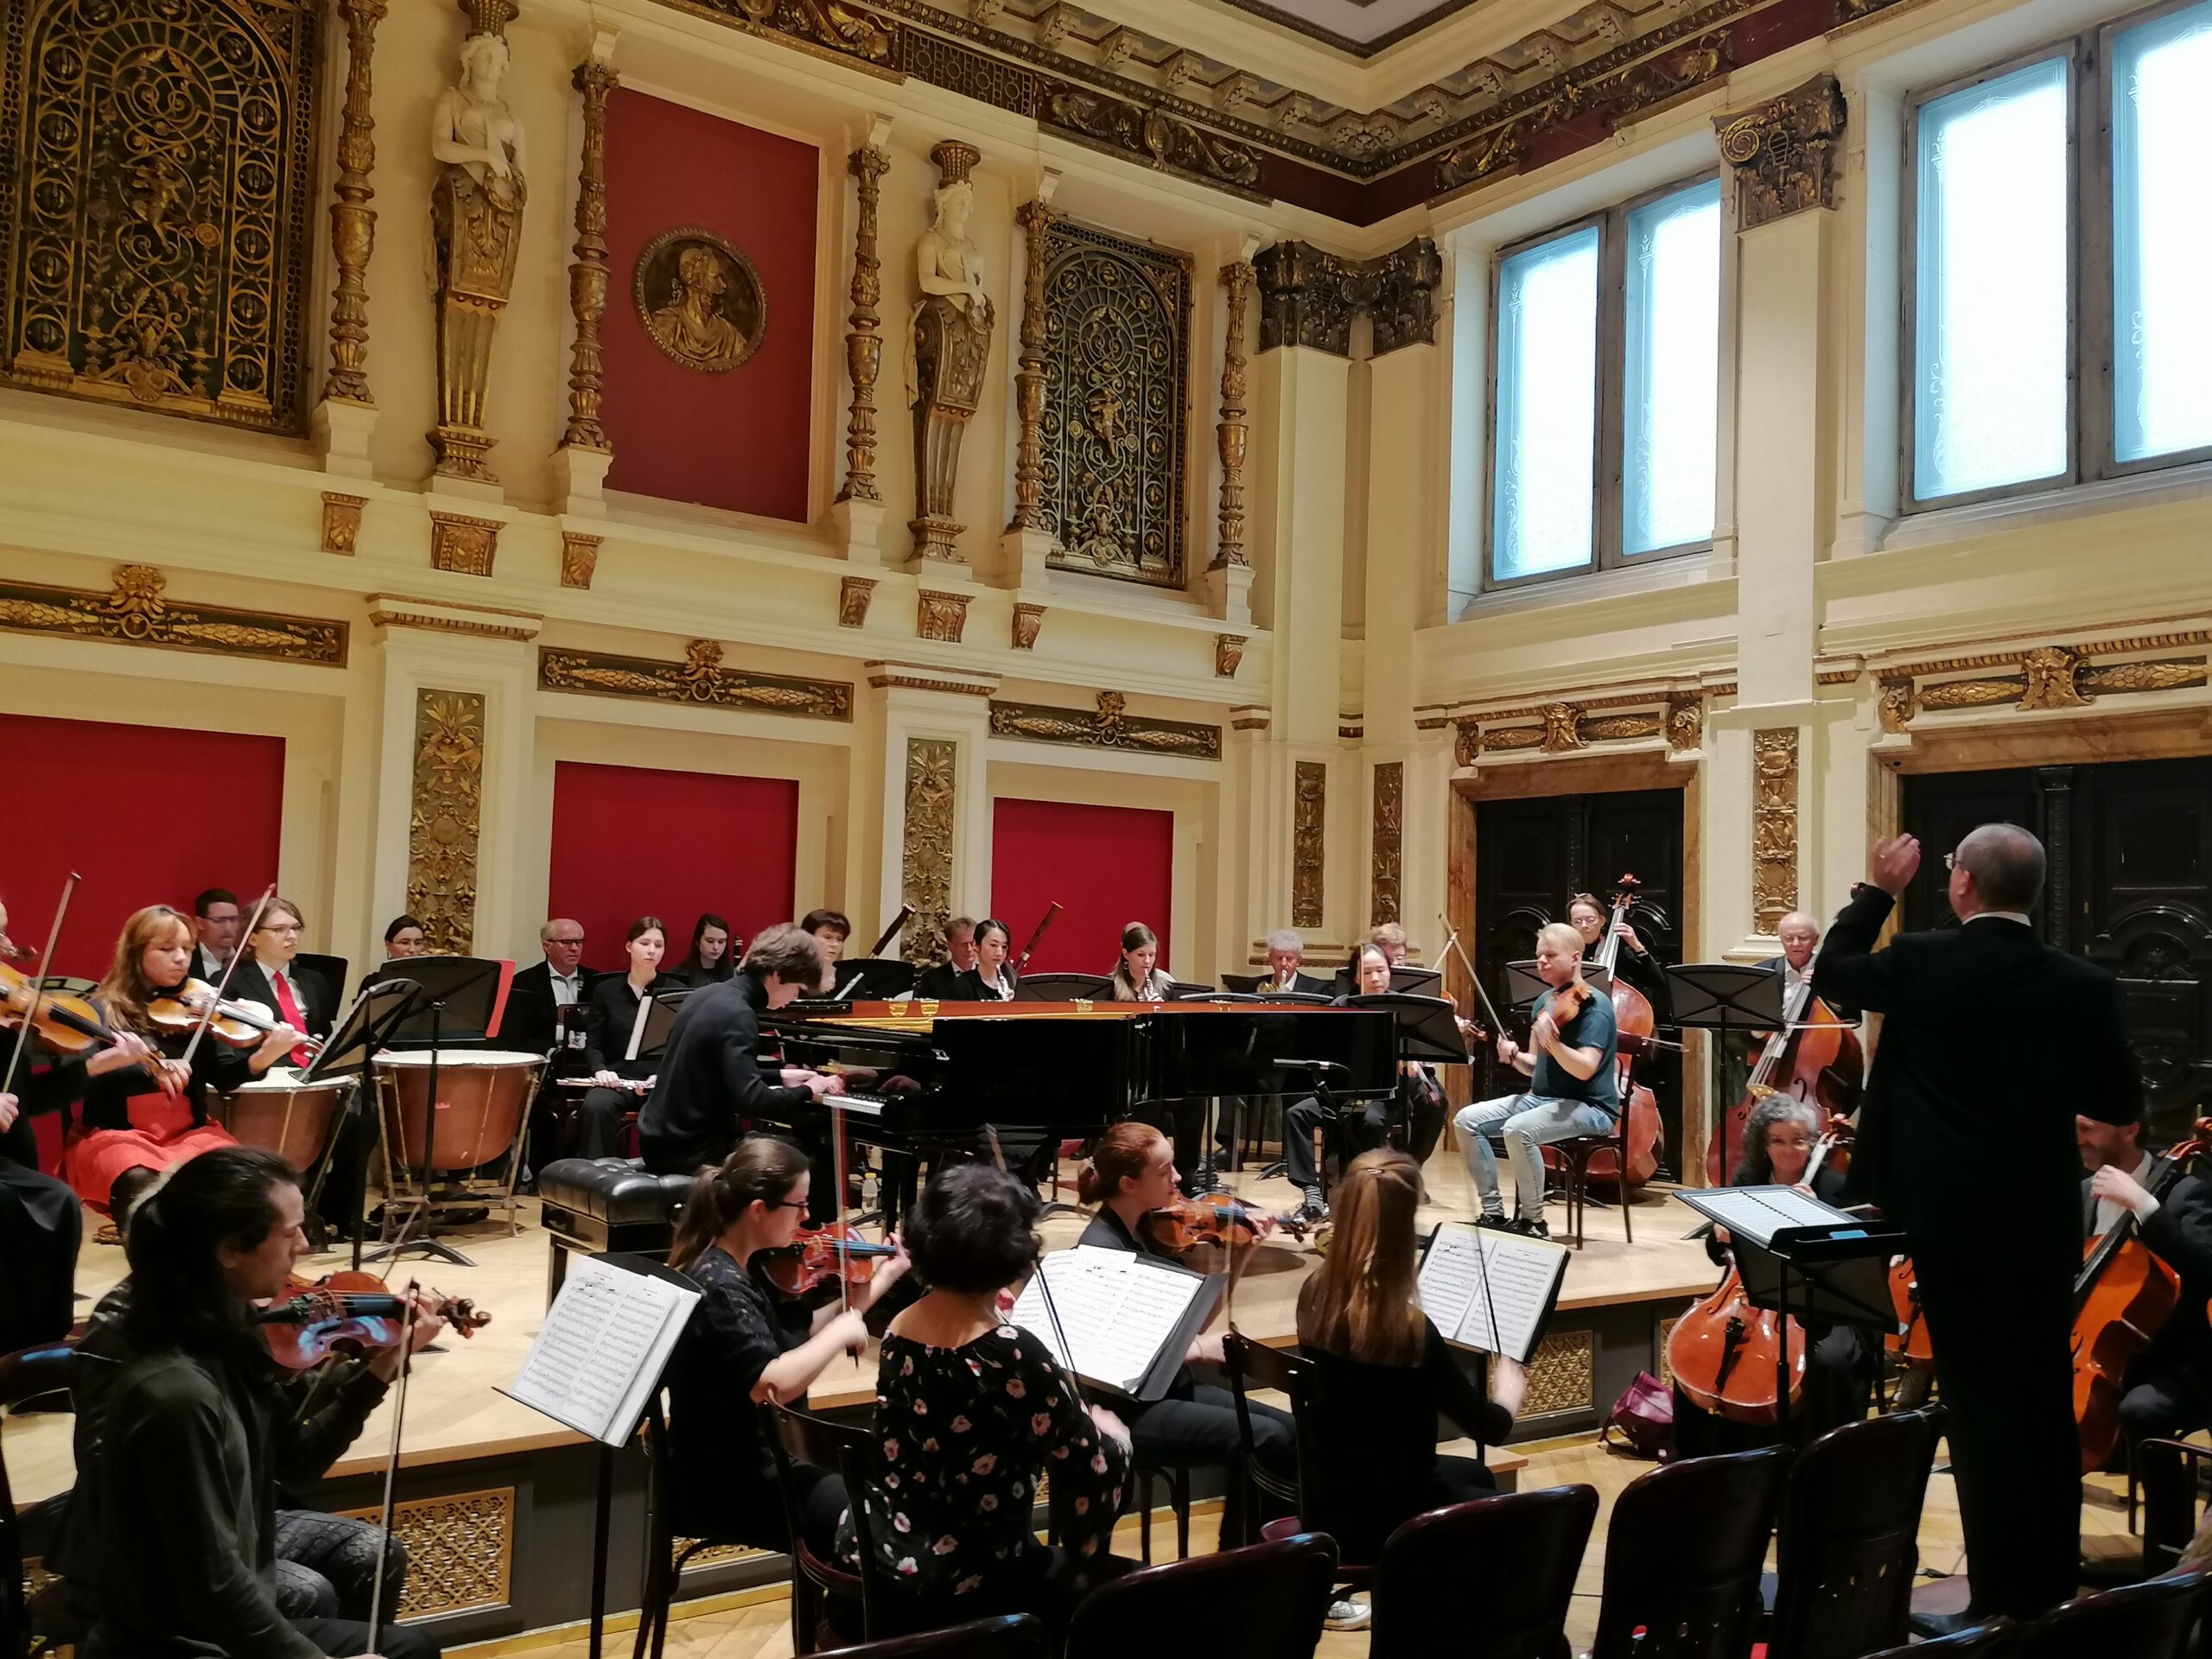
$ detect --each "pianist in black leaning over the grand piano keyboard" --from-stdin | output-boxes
[637,923,845,1214]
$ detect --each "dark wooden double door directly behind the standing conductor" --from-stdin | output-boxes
[1900,757,2212,1144]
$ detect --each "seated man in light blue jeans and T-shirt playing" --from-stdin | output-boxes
[1451,923,1621,1239]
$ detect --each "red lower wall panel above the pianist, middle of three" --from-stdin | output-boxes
[546,761,798,971]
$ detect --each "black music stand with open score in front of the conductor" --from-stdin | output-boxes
[1675,1185,1909,1446]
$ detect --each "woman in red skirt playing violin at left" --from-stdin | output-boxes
[64,905,301,1208]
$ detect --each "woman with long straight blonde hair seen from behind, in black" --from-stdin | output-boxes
[1299,1148,1529,1628]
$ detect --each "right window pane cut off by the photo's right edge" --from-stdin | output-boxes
[2113,7,2212,460]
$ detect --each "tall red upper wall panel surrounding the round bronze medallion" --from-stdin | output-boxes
[600,91,821,522]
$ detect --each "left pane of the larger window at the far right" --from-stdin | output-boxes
[1913,58,2070,500]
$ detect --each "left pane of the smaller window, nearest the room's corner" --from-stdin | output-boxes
[1491,226,1597,580]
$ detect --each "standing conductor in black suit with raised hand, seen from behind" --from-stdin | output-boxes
[1814,823,2141,1630]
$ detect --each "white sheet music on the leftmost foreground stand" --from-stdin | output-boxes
[500,1256,699,1446]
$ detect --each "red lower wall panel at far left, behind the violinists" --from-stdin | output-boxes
[0,715,285,1168]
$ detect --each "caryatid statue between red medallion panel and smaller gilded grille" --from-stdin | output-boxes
[907,139,991,564]
